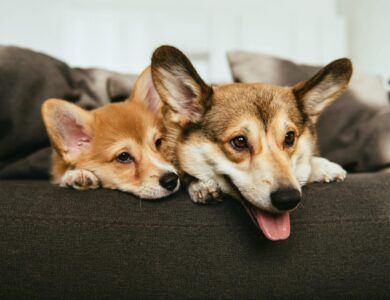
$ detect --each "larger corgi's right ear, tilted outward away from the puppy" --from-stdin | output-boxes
[293,58,352,122]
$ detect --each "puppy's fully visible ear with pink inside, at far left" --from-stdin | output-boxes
[41,99,93,163]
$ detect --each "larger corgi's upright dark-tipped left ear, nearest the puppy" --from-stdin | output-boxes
[151,46,212,125]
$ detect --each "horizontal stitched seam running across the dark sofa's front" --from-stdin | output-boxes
[0,215,390,228]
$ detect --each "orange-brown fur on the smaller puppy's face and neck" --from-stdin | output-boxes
[43,99,161,185]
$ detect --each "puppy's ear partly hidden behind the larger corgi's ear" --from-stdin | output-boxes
[130,66,162,114]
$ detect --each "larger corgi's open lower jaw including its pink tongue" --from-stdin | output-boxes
[241,200,291,241]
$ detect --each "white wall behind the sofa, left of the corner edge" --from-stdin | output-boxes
[0,0,348,82]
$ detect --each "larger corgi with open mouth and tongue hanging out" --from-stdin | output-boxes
[151,46,352,240]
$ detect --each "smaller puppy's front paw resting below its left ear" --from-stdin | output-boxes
[60,169,100,190]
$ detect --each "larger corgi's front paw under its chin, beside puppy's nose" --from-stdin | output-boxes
[188,180,222,204]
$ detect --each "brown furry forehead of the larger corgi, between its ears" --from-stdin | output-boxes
[205,83,301,131]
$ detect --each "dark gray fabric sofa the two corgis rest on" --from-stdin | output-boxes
[0,46,390,299]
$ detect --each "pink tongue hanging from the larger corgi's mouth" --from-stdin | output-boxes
[252,208,290,241]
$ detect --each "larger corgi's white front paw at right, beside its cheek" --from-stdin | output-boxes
[309,157,347,182]
